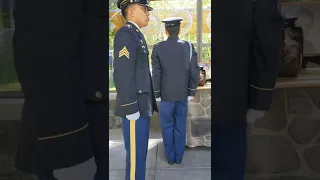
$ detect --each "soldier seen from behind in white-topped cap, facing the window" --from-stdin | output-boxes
[151,17,200,164]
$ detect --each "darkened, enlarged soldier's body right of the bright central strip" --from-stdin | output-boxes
[211,0,284,180]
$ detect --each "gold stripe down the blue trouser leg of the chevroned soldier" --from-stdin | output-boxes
[129,120,136,180]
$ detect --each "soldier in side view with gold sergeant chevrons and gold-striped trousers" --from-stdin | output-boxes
[113,0,158,180]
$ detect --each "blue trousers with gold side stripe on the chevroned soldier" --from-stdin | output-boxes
[122,117,150,180]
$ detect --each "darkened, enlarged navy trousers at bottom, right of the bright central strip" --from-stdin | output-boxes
[211,123,247,180]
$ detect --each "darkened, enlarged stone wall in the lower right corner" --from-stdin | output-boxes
[247,88,320,180]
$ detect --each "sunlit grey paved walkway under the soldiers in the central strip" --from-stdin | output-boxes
[109,130,211,180]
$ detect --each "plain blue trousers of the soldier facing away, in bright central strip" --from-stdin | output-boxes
[160,100,188,163]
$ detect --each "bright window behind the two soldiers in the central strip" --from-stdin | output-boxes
[109,0,211,92]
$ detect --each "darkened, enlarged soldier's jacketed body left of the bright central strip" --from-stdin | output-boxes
[13,0,109,180]
